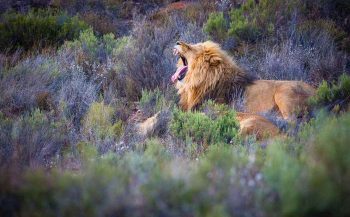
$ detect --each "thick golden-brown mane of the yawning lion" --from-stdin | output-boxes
[178,41,254,110]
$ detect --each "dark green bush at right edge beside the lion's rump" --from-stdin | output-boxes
[310,74,350,110]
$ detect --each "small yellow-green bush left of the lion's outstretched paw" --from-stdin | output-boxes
[83,102,123,141]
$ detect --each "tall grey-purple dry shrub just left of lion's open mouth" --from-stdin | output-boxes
[117,15,205,100]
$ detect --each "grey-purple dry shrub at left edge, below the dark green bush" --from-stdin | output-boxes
[0,56,58,116]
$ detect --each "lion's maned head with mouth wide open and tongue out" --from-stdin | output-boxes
[171,41,253,110]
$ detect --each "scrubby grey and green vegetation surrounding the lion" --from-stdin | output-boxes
[0,0,350,217]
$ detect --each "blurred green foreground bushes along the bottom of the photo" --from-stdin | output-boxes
[0,112,350,217]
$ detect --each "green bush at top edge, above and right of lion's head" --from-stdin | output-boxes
[204,0,302,42]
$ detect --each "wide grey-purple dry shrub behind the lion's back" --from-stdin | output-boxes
[239,27,348,85]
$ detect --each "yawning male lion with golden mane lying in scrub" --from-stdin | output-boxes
[172,41,315,120]
